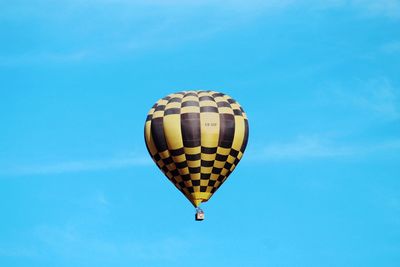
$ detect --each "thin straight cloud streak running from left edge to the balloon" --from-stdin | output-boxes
[0,155,152,176]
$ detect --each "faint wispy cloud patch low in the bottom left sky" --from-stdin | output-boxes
[0,223,193,265]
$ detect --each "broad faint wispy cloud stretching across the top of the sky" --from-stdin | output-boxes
[0,0,400,66]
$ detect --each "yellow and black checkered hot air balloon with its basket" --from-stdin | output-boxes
[144,91,249,220]
